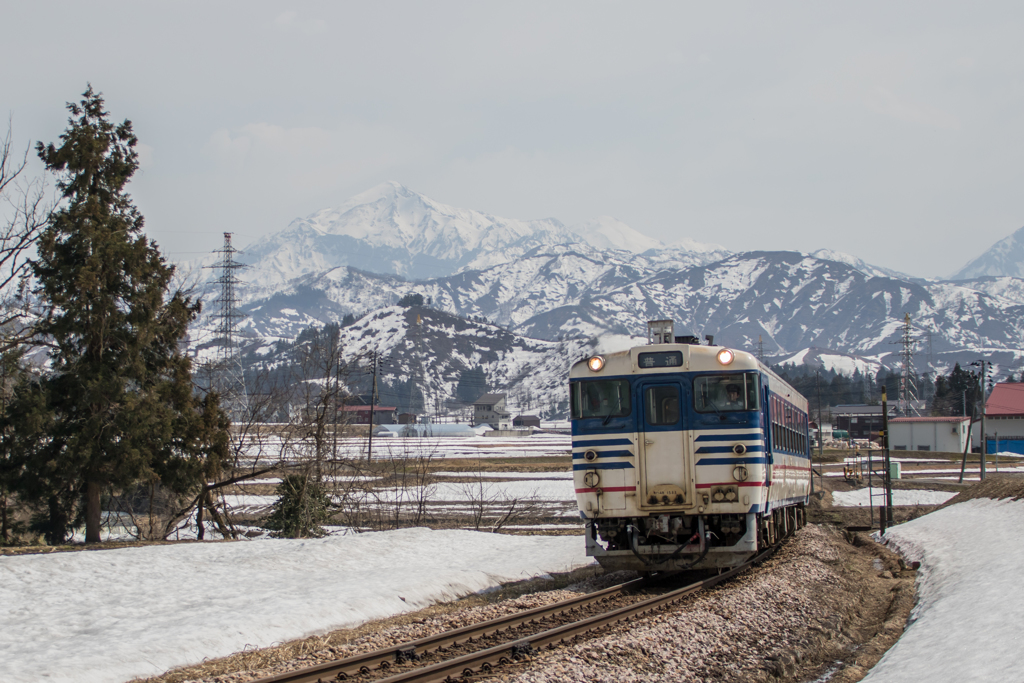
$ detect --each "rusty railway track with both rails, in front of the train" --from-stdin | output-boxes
[249,546,778,683]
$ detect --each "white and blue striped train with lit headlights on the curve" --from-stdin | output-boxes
[569,321,812,573]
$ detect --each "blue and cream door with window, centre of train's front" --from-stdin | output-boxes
[638,381,694,510]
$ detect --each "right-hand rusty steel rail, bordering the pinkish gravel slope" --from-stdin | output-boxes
[372,546,778,683]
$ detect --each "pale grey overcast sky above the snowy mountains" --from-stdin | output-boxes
[0,0,1024,276]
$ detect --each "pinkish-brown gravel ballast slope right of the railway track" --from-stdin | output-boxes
[493,525,913,683]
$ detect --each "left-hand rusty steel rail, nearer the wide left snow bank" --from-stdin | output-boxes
[254,579,649,683]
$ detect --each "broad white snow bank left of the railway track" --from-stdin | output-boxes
[0,528,591,683]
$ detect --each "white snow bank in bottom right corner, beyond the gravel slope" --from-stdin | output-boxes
[863,499,1024,683]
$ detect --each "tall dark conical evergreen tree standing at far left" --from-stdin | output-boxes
[4,86,227,543]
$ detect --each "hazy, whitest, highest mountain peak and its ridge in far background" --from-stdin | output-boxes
[234,182,728,286]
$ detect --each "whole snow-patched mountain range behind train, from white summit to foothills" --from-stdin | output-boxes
[191,183,1024,405]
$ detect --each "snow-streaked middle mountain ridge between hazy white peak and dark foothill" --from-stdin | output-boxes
[198,245,1024,382]
